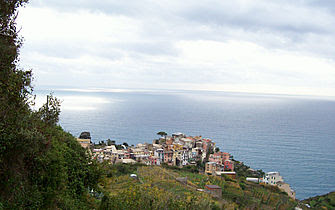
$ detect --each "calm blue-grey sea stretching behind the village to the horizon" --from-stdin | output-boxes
[37,91,335,199]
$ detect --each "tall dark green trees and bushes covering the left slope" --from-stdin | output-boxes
[0,0,101,209]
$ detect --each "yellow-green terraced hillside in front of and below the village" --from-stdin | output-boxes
[100,164,297,209]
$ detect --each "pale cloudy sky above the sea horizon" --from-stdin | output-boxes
[18,0,335,96]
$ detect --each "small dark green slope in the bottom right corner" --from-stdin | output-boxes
[302,192,335,209]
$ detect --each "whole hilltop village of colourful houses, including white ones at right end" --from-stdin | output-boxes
[77,131,295,199]
